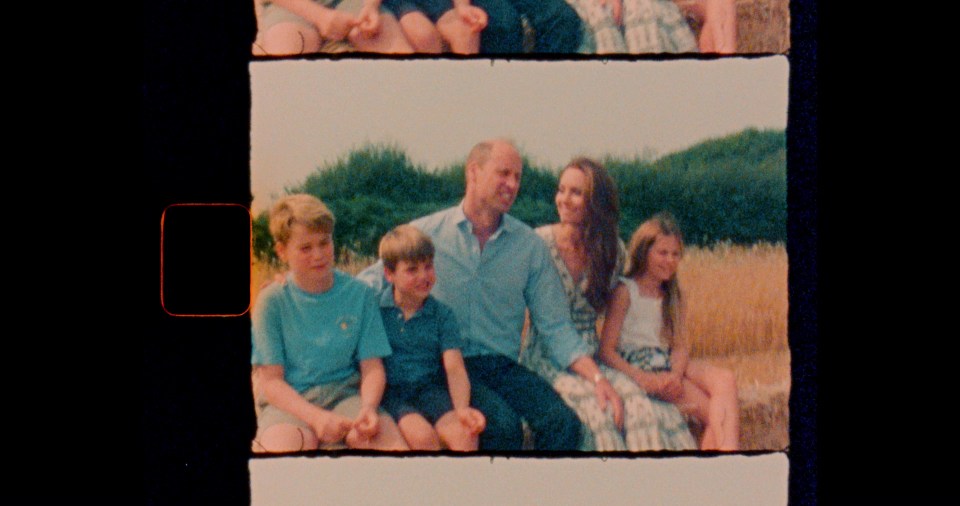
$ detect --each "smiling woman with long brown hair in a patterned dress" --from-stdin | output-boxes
[521,158,696,451]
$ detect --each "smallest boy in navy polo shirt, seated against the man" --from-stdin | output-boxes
[372,225,486,451]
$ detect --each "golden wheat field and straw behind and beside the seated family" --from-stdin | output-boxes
[251,243,790,450]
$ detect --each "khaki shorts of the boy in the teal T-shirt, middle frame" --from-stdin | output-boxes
[254,374,386,450]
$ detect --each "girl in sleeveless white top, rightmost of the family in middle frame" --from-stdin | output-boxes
[599,213,740,451]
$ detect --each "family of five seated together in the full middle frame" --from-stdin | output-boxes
[252,139,740,452]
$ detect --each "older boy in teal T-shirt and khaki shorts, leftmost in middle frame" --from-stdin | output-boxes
[251,195,406,452]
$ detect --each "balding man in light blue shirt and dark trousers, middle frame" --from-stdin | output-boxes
[358,139,622,450]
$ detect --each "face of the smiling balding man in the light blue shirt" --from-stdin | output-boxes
[468,143,523,214]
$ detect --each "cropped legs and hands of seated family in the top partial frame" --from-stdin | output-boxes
[257,0,737,56]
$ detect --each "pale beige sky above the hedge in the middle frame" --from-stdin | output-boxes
[250,56,789,214]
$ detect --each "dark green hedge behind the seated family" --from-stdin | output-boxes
[254,129,787,261]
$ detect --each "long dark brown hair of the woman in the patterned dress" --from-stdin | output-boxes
[560,157,620,313]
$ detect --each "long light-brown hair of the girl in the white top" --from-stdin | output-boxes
[624,211,683,346]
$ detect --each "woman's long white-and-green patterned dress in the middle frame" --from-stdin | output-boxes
[520,225,697,451]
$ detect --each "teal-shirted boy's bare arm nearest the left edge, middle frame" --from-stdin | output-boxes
[254,365,352,443]
